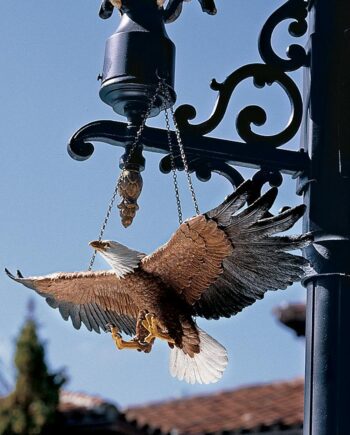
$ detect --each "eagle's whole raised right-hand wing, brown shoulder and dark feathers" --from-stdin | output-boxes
[142,180,312,319]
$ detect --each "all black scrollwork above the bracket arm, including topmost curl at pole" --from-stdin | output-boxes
[176,0,307,147]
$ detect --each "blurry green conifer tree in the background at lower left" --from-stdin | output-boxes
[0,319,64,435]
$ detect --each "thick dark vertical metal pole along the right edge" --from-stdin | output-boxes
[303,0,350,435]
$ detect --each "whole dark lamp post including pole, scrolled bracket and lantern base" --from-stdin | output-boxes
[68,0,350,435]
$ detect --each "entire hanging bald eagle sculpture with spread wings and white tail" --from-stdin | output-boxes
[6,180,312,383]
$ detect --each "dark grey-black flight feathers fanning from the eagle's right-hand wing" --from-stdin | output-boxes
[194,183,312,319]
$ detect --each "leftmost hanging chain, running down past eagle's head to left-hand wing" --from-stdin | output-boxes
[88,80,163,271]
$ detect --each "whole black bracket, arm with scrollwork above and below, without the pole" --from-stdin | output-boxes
[68,0,309,193]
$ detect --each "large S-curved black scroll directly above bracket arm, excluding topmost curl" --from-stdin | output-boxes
[175,64,303,147]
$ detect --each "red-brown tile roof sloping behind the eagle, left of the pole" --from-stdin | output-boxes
[125,379,304,435]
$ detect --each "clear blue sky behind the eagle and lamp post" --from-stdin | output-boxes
[0,0,305,406]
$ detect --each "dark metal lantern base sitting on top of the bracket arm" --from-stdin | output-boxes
[100,0,176,118]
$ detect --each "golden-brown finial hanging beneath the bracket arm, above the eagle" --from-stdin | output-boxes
[118,169,143,228]
